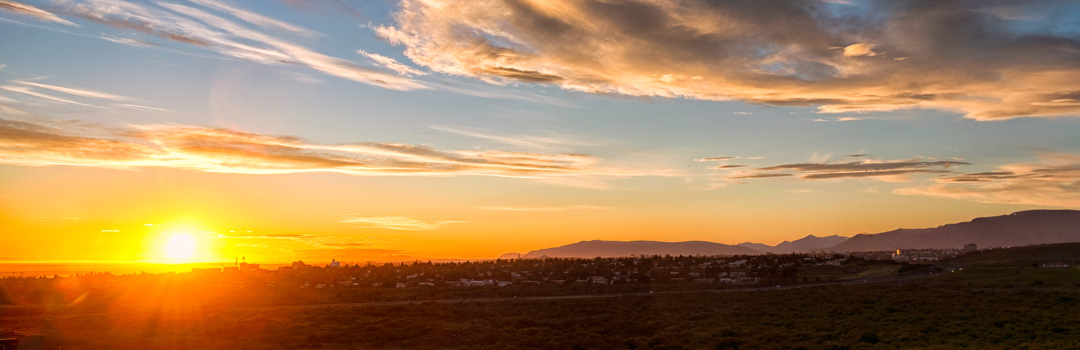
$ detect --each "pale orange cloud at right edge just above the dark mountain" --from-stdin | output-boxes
[893,152,1080,207]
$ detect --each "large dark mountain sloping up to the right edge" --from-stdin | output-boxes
[819,211,1080,252]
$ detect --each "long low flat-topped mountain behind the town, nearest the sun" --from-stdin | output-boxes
[522,241,760,258]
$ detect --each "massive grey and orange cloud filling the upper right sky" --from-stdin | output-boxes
[376,0,1080,120]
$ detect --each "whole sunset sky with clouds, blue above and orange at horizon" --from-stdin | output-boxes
[0,0,1080,263]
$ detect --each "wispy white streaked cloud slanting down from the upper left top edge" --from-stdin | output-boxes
[50,0,431,91]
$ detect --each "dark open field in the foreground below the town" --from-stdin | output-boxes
[0,246,1080,350]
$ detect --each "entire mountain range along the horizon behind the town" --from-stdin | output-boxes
[500,210,1080,258]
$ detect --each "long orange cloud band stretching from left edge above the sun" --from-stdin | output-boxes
[0,119,659,181]
